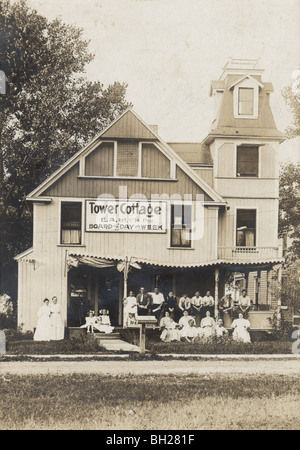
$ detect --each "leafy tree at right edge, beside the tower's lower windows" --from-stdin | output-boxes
[279,163,300,260]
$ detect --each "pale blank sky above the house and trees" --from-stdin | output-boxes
[28,0,300,162]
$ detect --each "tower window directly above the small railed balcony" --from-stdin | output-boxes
[236,209,256,247]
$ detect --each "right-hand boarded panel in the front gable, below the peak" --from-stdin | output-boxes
[142,144,170,178]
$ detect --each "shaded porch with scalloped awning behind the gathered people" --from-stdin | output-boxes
[68,255,281,329]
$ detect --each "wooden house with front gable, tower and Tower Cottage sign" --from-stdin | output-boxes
[16,60,284,330]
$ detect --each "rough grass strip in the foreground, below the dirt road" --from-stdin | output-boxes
[0,374,300,430]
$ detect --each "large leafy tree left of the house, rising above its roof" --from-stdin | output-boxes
[0,0,129,295]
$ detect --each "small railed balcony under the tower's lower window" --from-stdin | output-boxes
[218,246,282,263]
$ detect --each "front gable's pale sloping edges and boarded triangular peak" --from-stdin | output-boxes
[27,108,226,205]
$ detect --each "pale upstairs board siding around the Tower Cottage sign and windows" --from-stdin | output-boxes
[35,199,218,266]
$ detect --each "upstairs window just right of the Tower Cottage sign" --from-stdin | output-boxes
[171,205,192,247]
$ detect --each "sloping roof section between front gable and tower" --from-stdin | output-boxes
[168,142,213,166]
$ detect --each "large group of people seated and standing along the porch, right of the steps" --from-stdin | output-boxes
[124,288,251,342]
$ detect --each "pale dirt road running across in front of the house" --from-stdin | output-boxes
[0,359,300,376]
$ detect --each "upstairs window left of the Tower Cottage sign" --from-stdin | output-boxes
[61,202,81,244]
